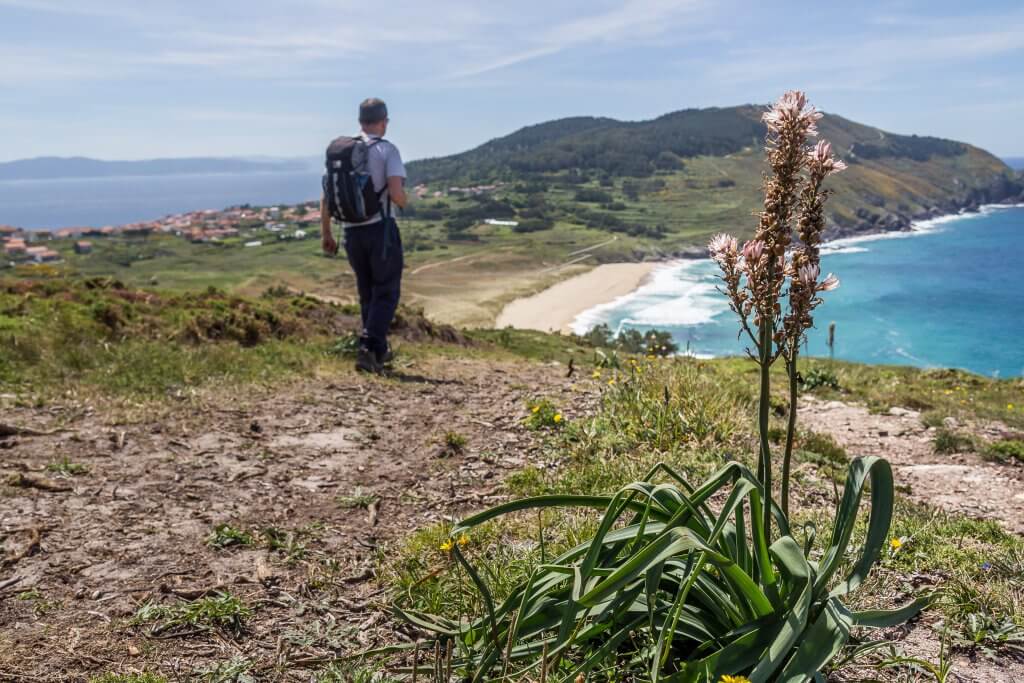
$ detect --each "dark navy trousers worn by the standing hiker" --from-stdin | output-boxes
[344,218,404,354]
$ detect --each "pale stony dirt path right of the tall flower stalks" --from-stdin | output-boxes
[799,396,1024,533]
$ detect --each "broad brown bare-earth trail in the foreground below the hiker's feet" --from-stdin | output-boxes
[0,359,585,681]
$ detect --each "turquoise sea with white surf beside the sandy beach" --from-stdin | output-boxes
[573,206,1024,377]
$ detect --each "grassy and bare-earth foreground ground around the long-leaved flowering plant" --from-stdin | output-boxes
[0,271,1024,683]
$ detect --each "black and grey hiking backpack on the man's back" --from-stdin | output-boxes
[324,136,387,223]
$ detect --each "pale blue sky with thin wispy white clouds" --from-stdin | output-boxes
[6,0,1024,161]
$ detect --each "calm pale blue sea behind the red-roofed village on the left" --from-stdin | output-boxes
[0,168,322,229]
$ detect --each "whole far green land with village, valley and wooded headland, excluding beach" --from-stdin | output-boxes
[9,102,1024,327]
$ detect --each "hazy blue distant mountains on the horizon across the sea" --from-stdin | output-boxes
[0,157,312,180]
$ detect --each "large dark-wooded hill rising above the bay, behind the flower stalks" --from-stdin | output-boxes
[409,105,1024,242]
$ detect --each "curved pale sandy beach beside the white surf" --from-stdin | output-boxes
[495,262,658,333]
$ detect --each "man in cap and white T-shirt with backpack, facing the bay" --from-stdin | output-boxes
[321,97,406,373]
